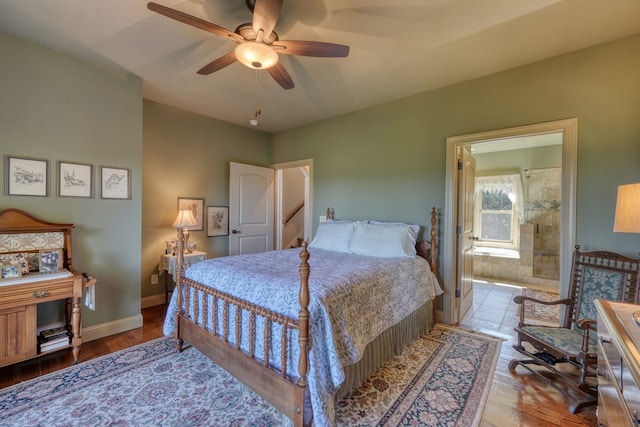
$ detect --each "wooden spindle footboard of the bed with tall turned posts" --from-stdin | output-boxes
[175,236,311,426]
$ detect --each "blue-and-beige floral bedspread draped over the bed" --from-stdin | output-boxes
[164,249,442,426]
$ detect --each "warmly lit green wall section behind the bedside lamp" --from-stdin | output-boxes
[141,101,271,304]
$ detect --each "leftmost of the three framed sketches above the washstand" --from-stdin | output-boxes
[5,156,49,197]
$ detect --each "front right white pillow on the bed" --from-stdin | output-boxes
[349,222,417,258]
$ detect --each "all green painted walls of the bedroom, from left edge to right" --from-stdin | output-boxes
[0,28,640,338]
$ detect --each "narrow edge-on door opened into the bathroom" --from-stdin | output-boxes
[456,146,476,322]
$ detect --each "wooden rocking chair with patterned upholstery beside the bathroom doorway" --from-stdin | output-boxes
[509,246,640,414]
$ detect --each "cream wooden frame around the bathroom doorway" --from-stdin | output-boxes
[438,119,577,324]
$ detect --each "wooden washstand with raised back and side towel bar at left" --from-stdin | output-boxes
[0,209,95,366]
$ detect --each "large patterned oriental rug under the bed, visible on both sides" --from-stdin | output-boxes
[0,325,501,427]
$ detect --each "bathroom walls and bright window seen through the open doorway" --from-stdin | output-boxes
[471,133,562,293]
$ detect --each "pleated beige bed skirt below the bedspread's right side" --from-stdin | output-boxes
[336,300,433,399]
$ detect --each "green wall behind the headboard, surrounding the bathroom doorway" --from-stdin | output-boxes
[274,35,640,256]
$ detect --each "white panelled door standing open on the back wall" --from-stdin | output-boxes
[229,162,274,255]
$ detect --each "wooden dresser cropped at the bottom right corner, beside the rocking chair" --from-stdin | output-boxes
[596,300,640,427]
